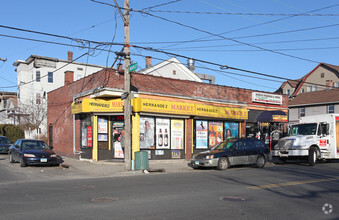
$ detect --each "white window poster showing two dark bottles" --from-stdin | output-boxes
[155,118,170,149]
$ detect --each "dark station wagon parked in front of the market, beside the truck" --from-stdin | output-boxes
[191,138,271,170]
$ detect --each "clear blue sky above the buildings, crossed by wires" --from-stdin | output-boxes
[0,0,339,92]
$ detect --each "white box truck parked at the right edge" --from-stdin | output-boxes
[272,114,339,166]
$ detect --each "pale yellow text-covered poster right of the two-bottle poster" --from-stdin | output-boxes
[171,119,184,150]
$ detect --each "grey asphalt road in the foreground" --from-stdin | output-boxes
[0,155,339,219]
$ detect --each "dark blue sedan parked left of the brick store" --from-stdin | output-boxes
[8,139,59,167]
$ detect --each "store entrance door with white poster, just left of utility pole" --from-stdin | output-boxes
[111,116,125,159]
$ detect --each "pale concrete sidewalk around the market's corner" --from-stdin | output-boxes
[60,156,192,176]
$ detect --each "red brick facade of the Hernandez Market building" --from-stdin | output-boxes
[47,70,288,155]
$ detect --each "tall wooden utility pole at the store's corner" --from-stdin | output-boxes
[124,0,132,170]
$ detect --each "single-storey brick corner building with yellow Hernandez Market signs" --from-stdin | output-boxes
[48,69,287,160]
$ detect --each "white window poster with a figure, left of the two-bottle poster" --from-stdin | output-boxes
[140,117,154,149]
